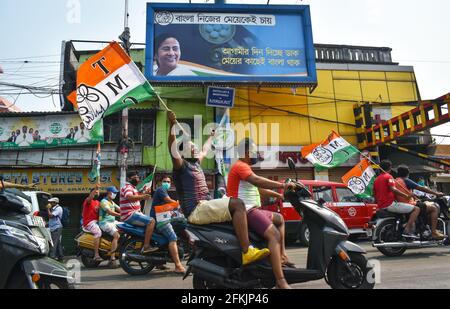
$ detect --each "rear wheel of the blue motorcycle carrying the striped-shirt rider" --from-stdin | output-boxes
[119,238,155,276]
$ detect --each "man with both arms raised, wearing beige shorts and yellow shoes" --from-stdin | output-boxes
[167,111,270,265]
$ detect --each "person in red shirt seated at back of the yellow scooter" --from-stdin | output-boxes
[82,186,103,261]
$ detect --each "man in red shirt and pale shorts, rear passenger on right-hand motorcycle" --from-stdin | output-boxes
[373,160,420,237]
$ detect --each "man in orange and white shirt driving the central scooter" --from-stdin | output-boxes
[227,138,296,289]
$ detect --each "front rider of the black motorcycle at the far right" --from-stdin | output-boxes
[395,165,445,240]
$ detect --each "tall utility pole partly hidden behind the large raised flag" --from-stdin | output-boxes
[119,0,131,188]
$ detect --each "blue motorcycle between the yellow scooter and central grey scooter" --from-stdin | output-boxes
[117,218,189,276]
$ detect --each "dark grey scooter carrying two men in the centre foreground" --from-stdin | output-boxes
[184,160,375,289]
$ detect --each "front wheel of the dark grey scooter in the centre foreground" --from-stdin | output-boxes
[327,252,375,290]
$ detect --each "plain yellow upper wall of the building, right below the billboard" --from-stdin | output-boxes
[231,70,418,146]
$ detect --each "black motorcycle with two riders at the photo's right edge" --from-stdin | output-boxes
[369,198,450,257]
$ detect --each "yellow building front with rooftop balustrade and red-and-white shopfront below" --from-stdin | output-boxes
[230,46,420,182]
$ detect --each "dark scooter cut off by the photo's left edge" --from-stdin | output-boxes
[0,177,73,289]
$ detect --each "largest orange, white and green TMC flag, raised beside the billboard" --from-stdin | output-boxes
[69,42,155,130]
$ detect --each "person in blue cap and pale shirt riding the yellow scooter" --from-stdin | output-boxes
[98,186,120,268]
